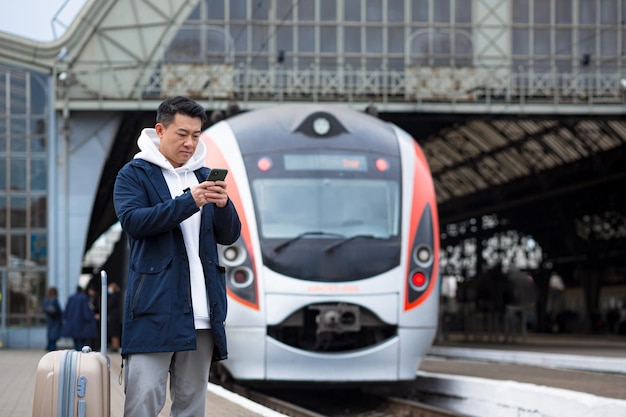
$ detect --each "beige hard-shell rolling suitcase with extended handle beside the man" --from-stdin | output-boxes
[33,271,111,417]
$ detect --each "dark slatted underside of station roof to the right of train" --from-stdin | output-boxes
[387,114,626,272]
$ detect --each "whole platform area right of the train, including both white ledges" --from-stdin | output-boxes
[417,333,626,417]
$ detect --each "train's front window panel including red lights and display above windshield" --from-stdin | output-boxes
[246,152,401,282]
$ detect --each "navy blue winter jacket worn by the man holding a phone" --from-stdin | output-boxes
[113,159,241,360]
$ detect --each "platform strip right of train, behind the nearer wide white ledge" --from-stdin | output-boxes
[420,333,626,400]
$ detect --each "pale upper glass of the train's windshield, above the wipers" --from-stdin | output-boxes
[253,178,400,239]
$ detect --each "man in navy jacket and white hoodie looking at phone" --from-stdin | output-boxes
[114,96,241,417]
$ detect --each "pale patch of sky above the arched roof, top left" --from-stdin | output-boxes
[0,0,87,42]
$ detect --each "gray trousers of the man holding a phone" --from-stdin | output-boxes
[124,329,213,417]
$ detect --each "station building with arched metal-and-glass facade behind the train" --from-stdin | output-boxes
[0,0,626,347]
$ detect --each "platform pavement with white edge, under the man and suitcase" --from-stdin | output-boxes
[0,349,284,417]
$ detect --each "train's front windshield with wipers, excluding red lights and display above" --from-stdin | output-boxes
[252,175,401,282]
